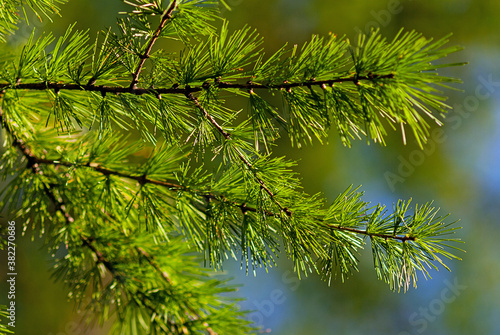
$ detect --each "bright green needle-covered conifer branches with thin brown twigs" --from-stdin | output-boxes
[0,0,458,334]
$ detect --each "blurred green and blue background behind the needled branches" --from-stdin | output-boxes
[0,0,500,335]
